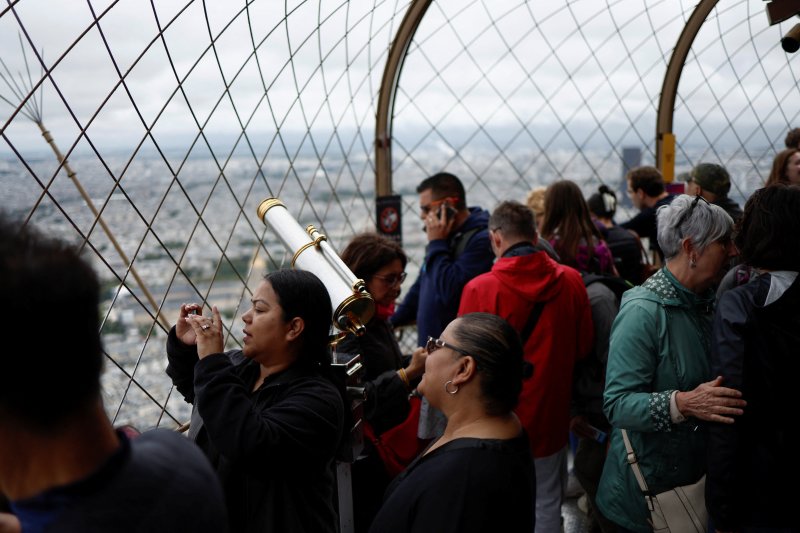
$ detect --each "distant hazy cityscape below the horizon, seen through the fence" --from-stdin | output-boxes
[0,148,771,427]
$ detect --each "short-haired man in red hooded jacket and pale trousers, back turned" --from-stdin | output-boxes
[458,202,594,533]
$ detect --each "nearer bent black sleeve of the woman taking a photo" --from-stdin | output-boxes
[194,354,344,471]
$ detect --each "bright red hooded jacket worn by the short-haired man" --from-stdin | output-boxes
[458,247,594,457]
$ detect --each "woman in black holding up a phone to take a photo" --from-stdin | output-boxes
[167,270,344,533]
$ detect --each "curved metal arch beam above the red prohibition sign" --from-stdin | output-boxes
[375,0,433,197]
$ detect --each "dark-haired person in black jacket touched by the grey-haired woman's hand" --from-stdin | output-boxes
[706,185,800,533]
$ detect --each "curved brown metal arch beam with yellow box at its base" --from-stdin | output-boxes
[656,0,718,183]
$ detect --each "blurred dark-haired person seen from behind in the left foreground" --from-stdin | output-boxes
[0,217,227,533]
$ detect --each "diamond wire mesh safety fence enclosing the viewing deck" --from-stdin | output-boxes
[0,0,798,428]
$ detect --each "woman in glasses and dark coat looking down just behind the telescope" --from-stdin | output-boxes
[336,233,425,532]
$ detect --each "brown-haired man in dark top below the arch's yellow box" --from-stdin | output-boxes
[620,166,675,264]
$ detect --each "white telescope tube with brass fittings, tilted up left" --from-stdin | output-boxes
[257,198,375,336]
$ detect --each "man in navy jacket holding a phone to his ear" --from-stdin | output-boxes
[390,172,494,439]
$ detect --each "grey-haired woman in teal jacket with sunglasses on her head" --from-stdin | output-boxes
[597,195,745,533]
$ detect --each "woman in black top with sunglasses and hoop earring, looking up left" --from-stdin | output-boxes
[370,313,536,533]
